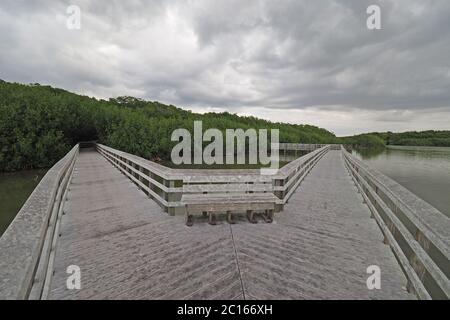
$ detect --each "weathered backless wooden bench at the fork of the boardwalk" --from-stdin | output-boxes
[181,192,278,226]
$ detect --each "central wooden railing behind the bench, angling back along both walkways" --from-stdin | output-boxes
[96,144,330,214]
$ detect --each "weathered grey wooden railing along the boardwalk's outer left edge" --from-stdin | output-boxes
[0,144,79,299]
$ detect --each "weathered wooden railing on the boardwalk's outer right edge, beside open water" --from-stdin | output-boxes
[343,149,450,299]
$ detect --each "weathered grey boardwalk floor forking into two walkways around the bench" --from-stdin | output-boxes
[49,151,415,299]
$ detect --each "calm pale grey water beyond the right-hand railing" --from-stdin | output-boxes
[352,146,450,217]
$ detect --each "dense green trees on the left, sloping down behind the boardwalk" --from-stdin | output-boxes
[0,81,338,172]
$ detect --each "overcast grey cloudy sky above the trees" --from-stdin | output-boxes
[0,0,450,135]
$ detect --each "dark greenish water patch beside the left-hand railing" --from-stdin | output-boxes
[0,170,46,236]
